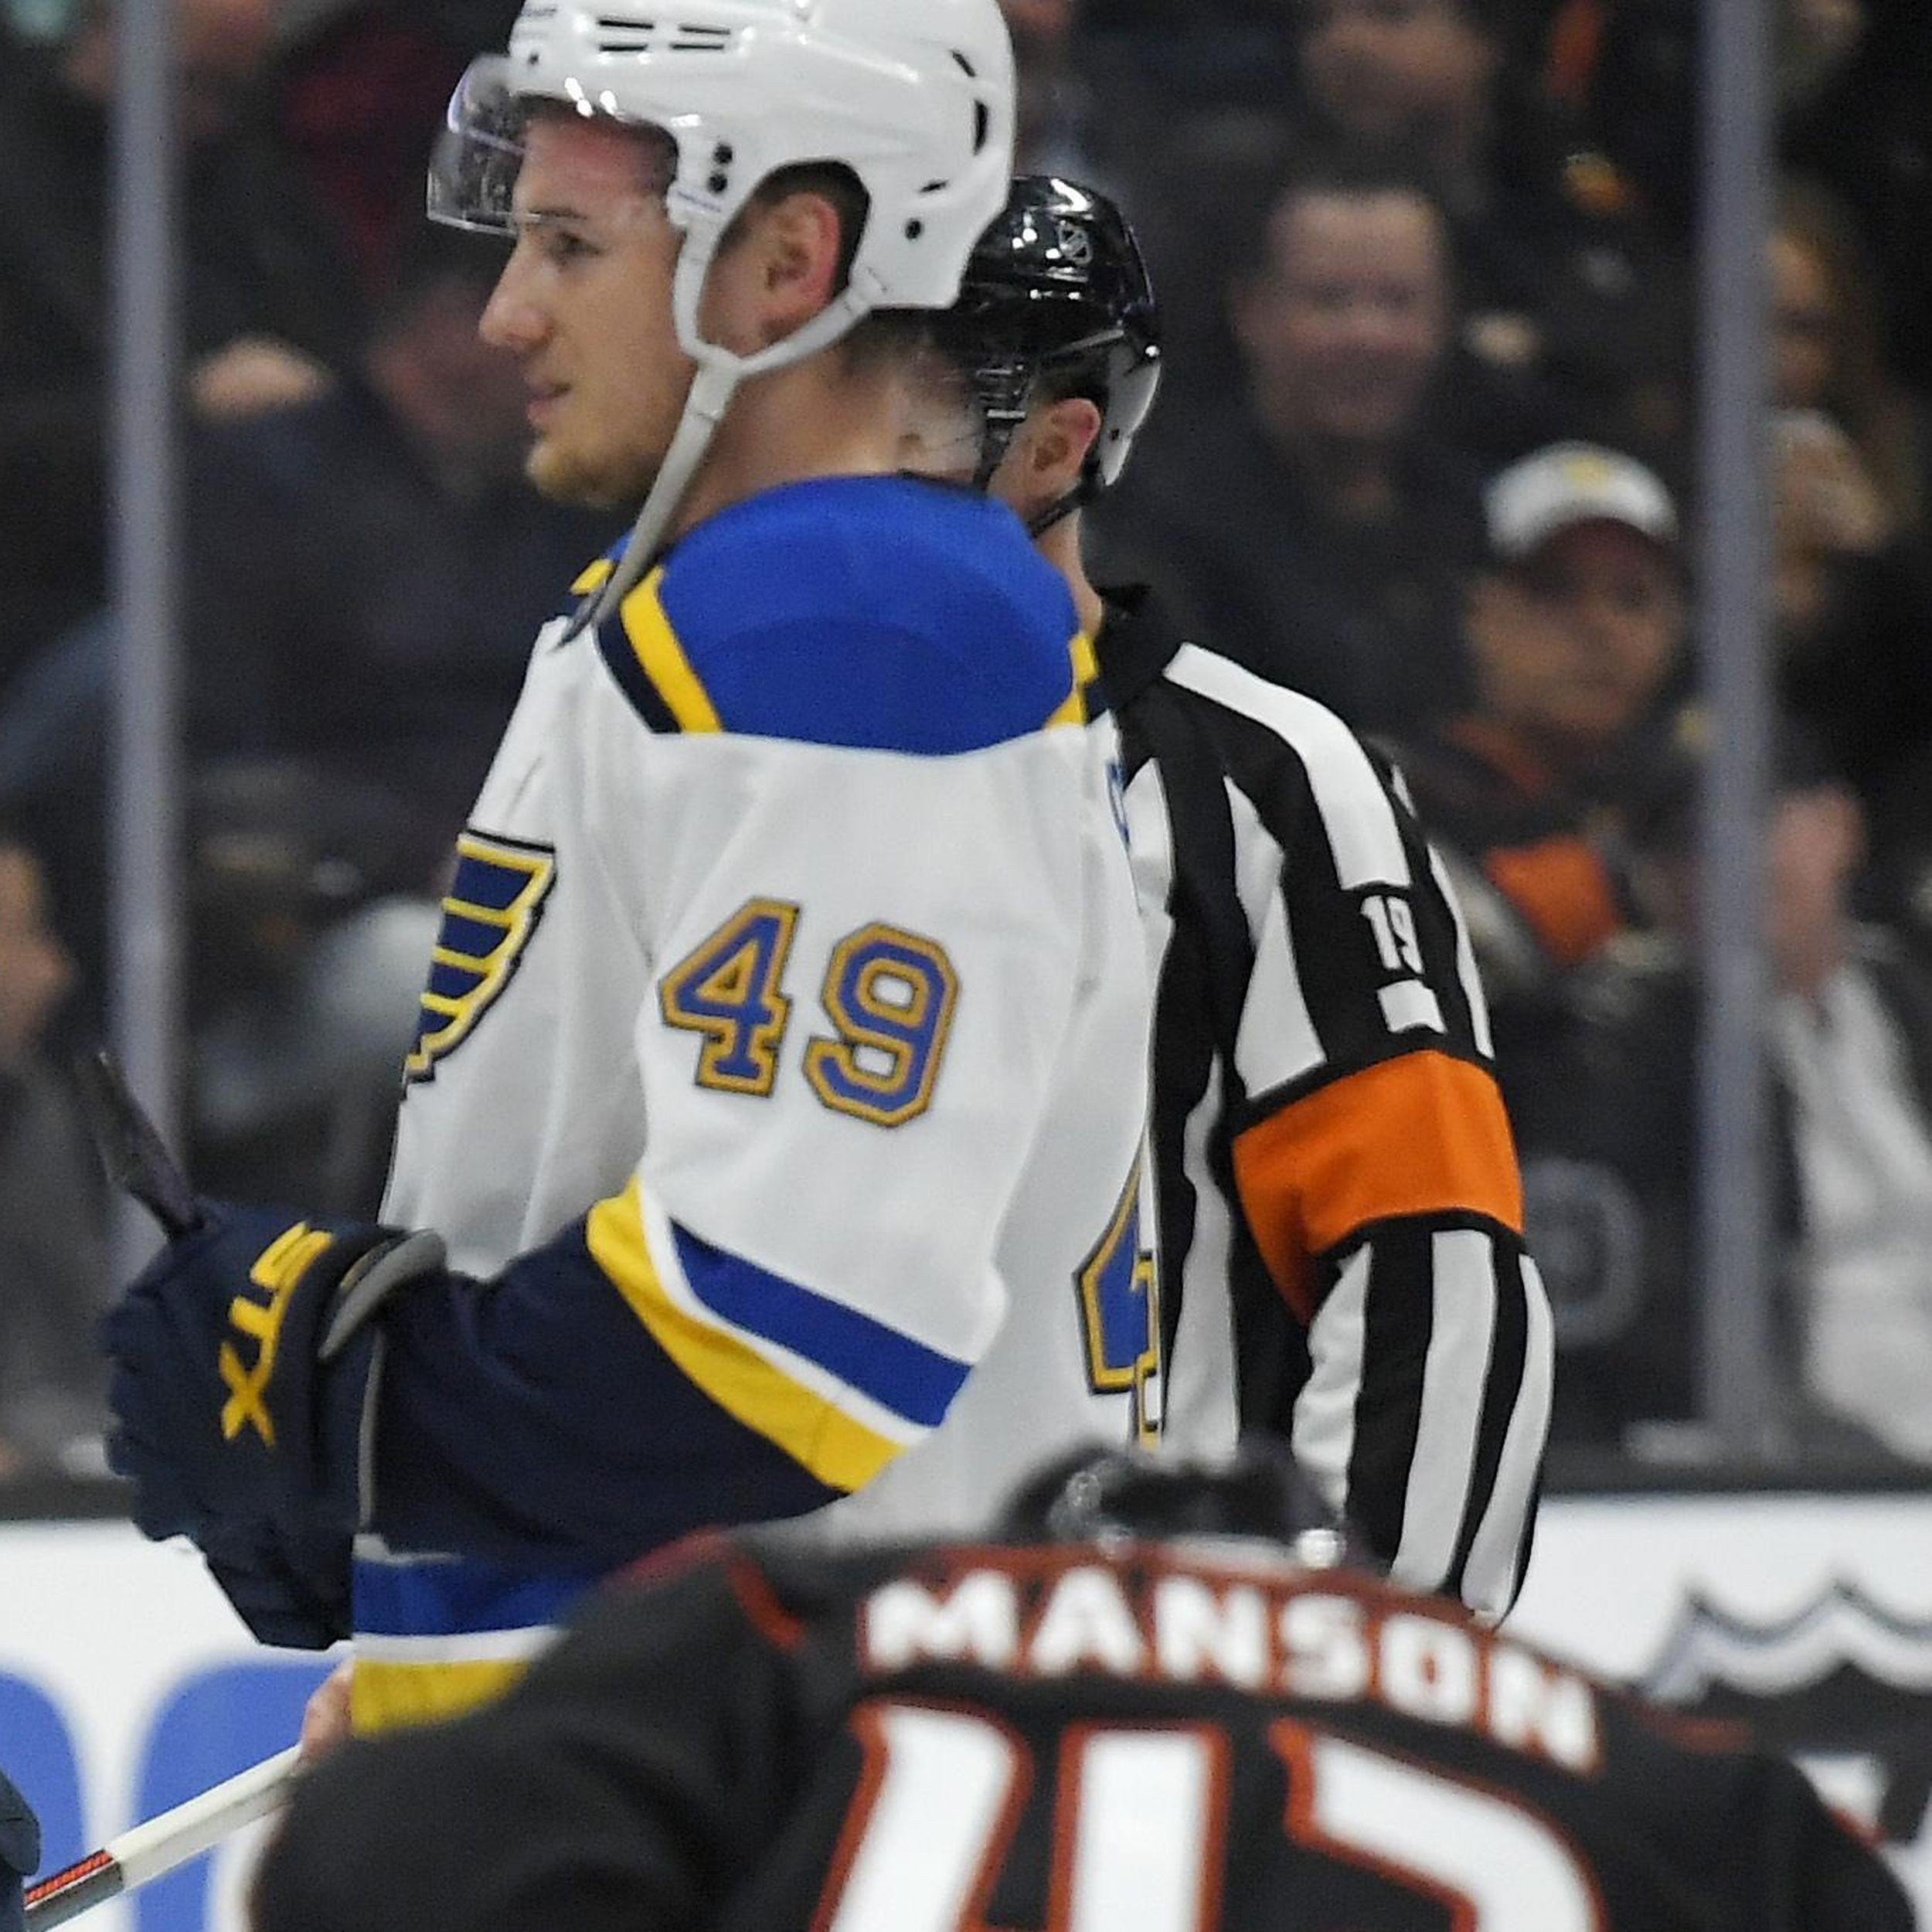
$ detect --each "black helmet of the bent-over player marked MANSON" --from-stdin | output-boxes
[1001,1437,1379,1569]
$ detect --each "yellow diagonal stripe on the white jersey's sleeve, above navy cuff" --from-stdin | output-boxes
[586,1181,904,1492]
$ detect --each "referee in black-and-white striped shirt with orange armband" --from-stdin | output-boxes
[916,176,1553,1617]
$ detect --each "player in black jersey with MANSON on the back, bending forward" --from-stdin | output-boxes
[255,1445,1913,1932]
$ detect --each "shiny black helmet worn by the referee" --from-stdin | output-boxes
[939,174,1162,514]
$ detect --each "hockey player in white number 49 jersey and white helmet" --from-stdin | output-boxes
[107,0,1154,1727]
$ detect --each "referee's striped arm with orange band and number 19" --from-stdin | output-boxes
[1233,726,1553,1617]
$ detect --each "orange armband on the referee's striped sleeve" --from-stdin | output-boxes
[1235,1053,1522,1321]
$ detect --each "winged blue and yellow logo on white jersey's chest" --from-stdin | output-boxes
[404,831,556,1080]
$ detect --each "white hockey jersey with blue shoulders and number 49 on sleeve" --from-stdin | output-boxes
[355,478,1158,1727]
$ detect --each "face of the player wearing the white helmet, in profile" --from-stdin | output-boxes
[483,116,692,509]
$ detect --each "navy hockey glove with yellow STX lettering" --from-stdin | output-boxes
[100,1206,443,1553]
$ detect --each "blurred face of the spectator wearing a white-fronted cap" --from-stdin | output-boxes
[1471,522,1685,756]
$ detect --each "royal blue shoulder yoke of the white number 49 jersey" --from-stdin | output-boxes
[599,478,1078,756]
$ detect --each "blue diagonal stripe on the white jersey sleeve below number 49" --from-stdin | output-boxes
[676,1229,972,1430]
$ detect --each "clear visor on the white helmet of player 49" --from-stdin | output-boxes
[429,54,676,236]
